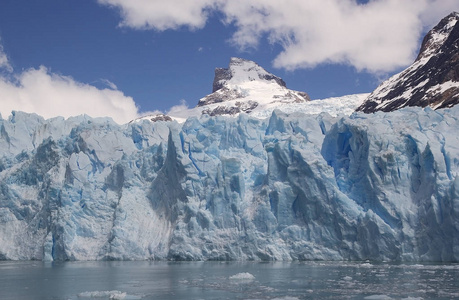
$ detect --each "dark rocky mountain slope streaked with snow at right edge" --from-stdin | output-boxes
[357,12,459,113]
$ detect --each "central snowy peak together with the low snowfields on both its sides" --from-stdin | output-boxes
[132,57,369,123]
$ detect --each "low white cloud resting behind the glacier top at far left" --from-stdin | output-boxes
[0,67,138,124]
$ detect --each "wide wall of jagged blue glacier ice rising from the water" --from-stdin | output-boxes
[0,106,459,262]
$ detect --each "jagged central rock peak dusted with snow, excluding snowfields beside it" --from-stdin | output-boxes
[198,57,310,116]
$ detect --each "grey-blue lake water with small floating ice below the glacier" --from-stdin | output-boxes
[0,261,459,300]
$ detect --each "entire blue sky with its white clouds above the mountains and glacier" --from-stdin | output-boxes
[0,0,459,124]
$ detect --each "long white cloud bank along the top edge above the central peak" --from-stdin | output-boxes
[99,0,458,73]
